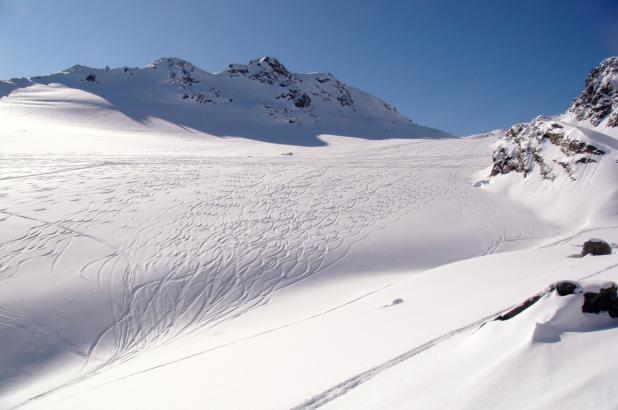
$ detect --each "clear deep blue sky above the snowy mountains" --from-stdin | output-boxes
[0,0,618,135]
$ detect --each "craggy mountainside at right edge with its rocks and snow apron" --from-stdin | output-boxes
[480,57,618,228]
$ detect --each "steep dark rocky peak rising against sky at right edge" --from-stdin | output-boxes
[569,57,618,127]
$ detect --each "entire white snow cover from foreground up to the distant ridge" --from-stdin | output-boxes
[0,58,618,409]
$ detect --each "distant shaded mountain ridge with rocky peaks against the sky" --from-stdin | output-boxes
[0,57,451,145]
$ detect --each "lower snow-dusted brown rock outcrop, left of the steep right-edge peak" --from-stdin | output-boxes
[491,116,605,180]
